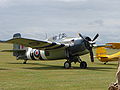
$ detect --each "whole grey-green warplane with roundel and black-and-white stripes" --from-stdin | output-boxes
[0,33,99,69]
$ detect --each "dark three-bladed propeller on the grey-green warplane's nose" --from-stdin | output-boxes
[78,33,99,62]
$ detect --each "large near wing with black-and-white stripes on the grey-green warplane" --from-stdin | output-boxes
[4,38,68,50]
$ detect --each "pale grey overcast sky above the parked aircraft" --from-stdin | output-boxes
[0,0,120,43]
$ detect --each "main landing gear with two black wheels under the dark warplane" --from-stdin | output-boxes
[64,57,87,69]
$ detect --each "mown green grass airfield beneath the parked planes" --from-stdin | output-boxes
[0,44,117,90]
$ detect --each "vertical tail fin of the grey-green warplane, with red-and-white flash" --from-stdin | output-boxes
[13,33,25,56]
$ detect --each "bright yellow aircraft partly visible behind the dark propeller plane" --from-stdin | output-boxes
[96,43,120,64]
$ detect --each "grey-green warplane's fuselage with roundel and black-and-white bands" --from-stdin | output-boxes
[25,38,89,60]
